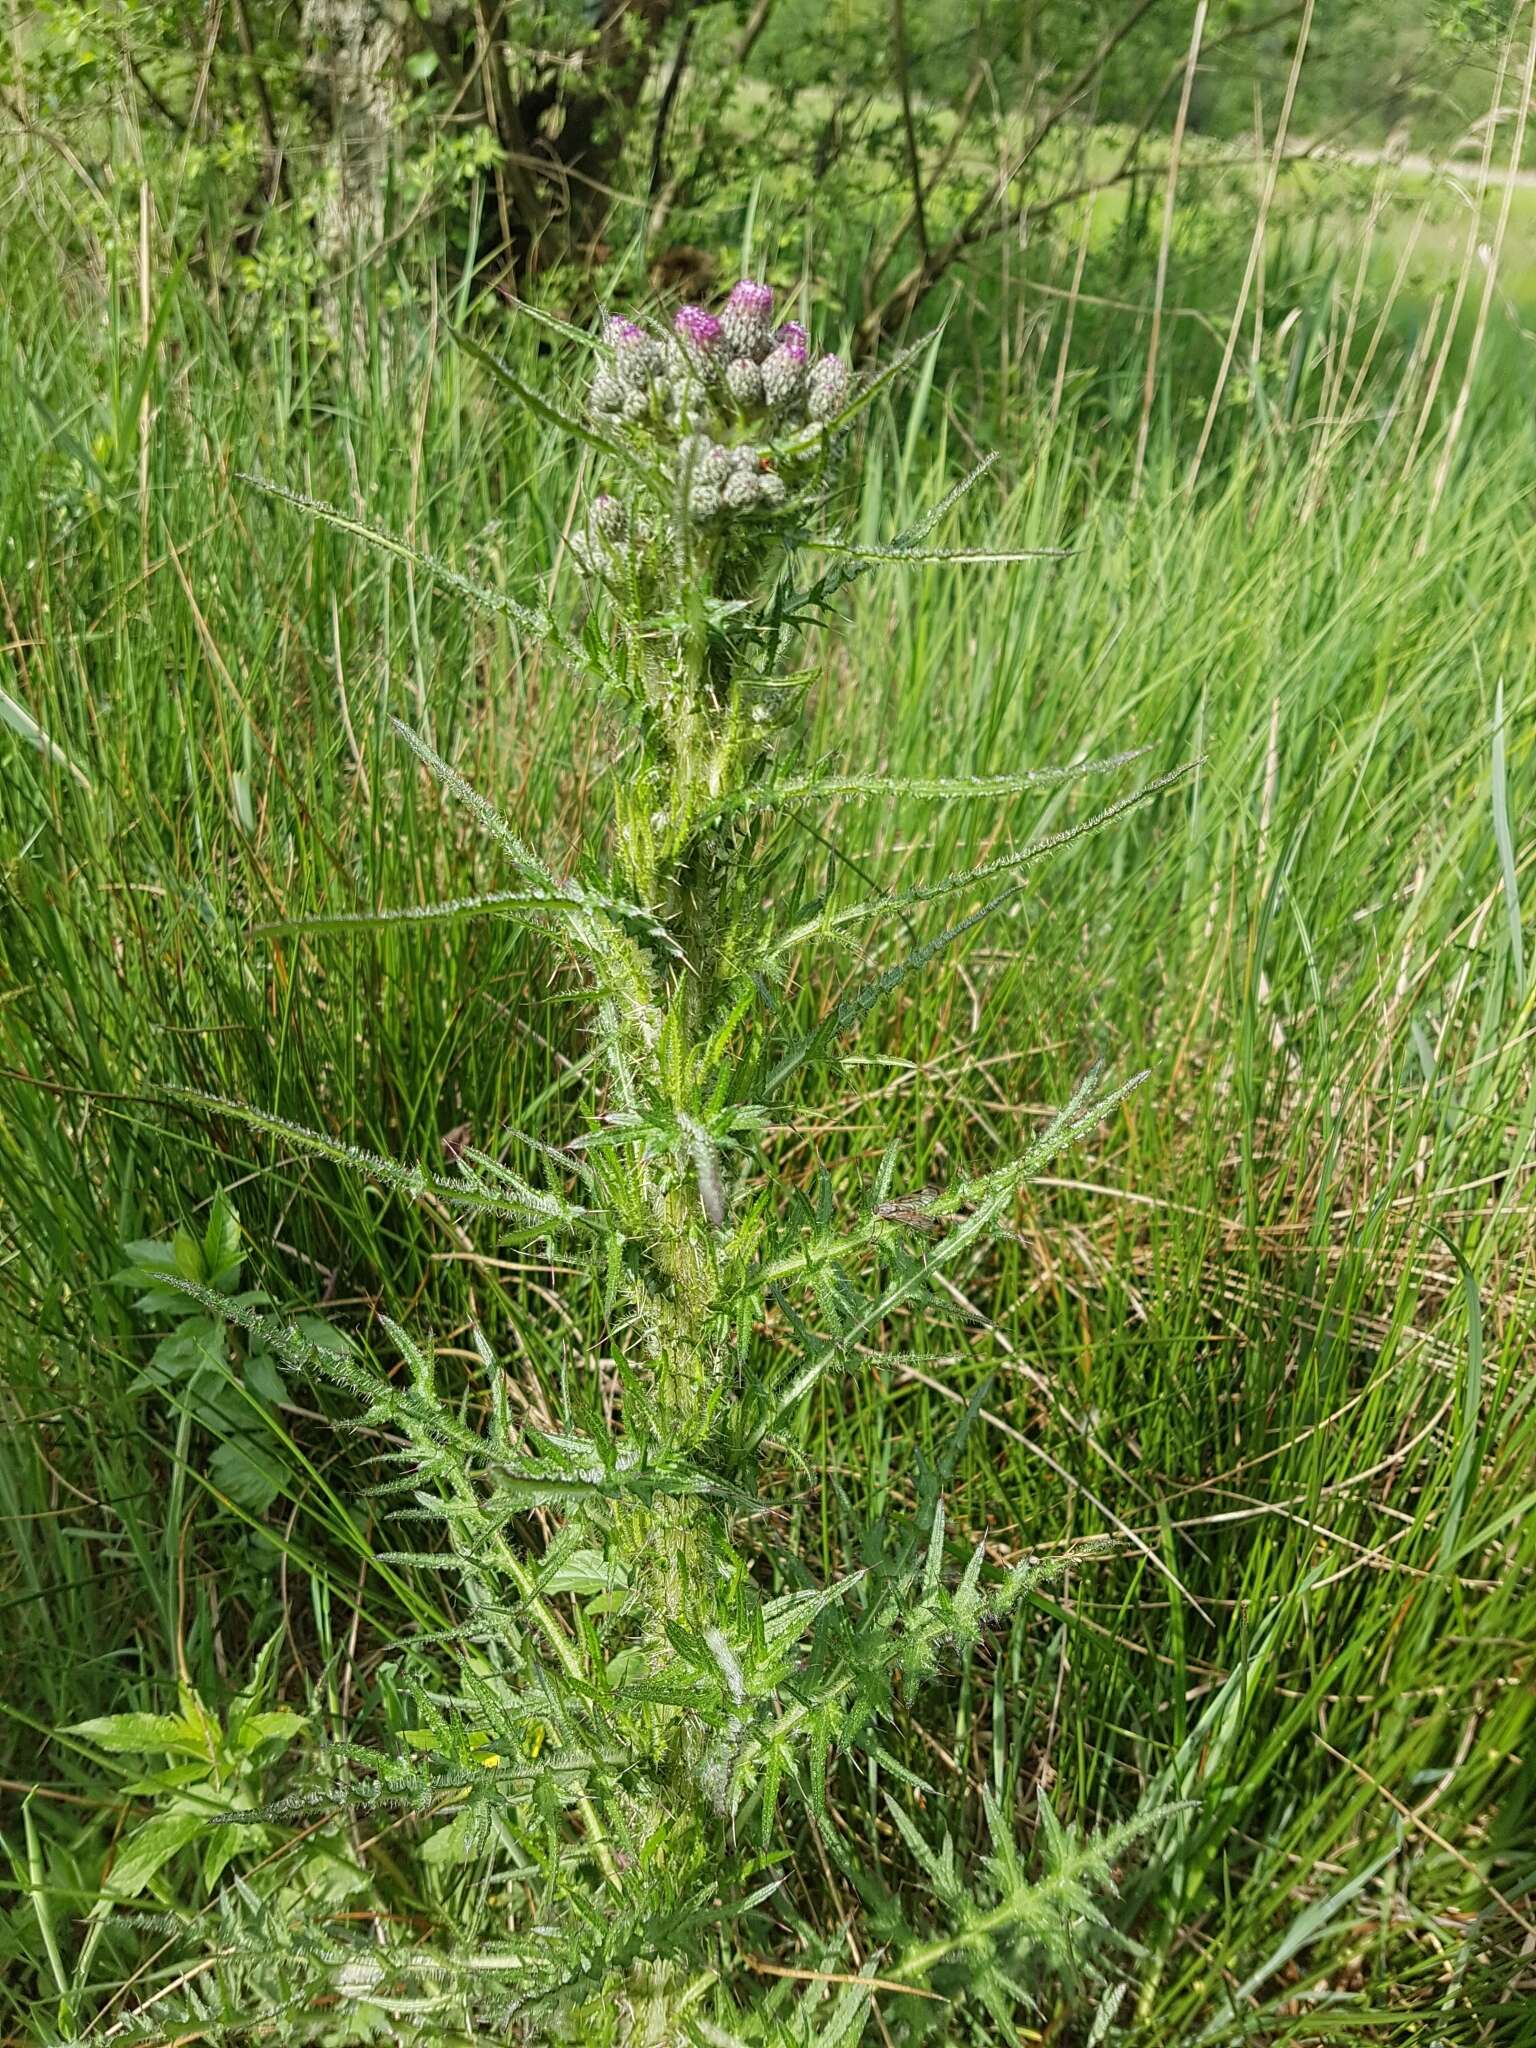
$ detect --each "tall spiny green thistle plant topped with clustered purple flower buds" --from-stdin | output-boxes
[156,281,1171,2048]
